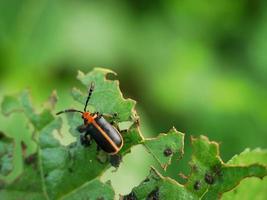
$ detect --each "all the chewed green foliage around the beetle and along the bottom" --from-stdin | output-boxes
[0,68,267,200]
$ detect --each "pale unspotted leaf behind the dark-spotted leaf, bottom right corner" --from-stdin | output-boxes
[222,149,267,200]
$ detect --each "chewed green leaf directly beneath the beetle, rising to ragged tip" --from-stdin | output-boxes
[39,69,143,199]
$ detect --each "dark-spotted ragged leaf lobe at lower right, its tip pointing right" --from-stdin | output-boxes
[185,136,267,199]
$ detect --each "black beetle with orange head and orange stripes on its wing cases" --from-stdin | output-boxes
[56,82,123,155]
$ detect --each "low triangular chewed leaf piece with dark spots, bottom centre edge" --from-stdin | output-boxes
[121,168,198,200]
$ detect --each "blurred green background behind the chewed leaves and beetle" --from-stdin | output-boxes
[0,0,267,197]
